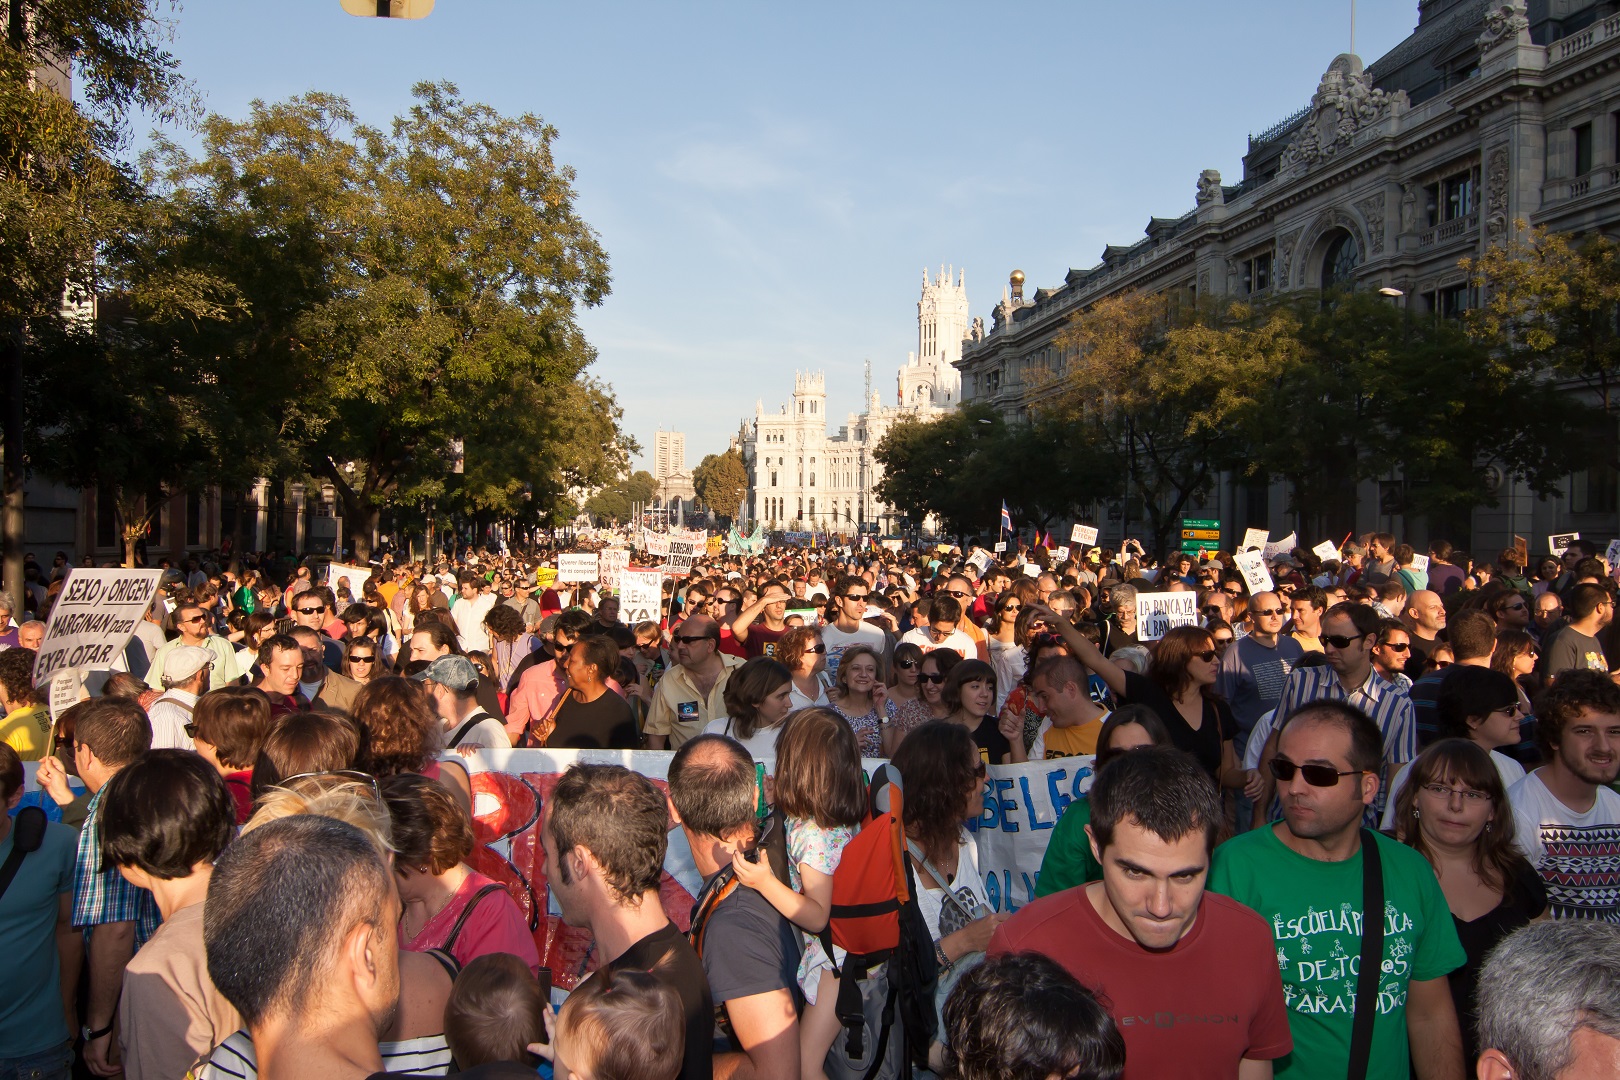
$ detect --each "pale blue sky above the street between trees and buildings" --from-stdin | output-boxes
[145,0,1418,468]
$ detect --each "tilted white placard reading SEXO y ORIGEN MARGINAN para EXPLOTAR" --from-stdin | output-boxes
[34,567,164,687]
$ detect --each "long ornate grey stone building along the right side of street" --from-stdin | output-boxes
[957,0,1620,552]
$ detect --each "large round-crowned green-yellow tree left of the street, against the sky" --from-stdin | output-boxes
[125,83,618,557]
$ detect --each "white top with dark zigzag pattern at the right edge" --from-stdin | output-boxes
[1508,769,1620,923]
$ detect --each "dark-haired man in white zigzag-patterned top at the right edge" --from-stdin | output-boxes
[1508,670,1620,923]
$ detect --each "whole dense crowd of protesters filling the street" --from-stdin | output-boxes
[0,534,1620,1080]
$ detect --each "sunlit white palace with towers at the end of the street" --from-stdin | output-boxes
[732,267,969,534]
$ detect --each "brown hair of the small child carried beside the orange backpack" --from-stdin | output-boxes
[773,708,867,829]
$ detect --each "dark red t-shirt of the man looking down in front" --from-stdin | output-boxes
[988,886,1294,1080]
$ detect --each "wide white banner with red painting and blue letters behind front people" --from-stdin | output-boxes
[456,750,1094,989]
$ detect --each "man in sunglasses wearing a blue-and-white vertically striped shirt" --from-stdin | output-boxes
[1277,604,1418,824]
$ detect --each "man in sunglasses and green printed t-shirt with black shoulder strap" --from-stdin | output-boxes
[1209,702,1468,1080]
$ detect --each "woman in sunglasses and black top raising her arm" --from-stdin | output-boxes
[1037,609,1246,787]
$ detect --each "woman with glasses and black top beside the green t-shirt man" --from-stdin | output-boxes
[1390,738,1547,1062]
